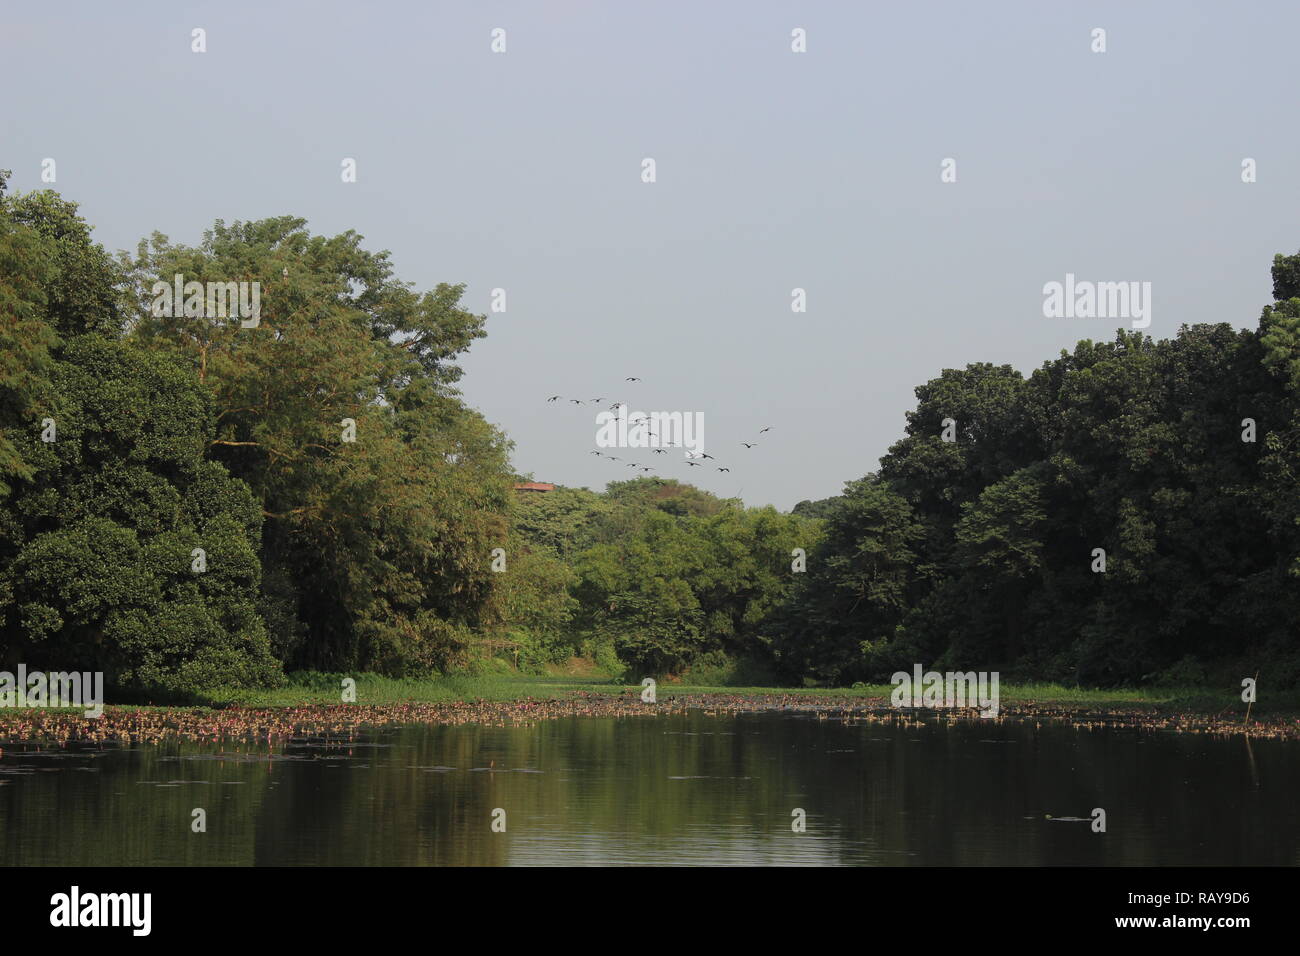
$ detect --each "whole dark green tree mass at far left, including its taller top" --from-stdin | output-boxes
[0,178,280,691]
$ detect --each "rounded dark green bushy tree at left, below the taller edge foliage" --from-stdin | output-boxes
[0,334,280,692]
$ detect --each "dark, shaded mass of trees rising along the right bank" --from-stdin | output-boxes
[779,264,1300,684]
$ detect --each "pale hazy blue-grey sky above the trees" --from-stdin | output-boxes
[0,0,1300,509]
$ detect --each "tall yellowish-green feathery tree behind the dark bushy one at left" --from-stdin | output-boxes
[124,217,508,672]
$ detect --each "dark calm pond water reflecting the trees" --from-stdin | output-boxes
[0,711,1300,866]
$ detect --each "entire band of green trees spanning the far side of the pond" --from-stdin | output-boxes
[0,173,1300,695]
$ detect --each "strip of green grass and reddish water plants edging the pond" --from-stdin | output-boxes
[0,675,1300,747]
